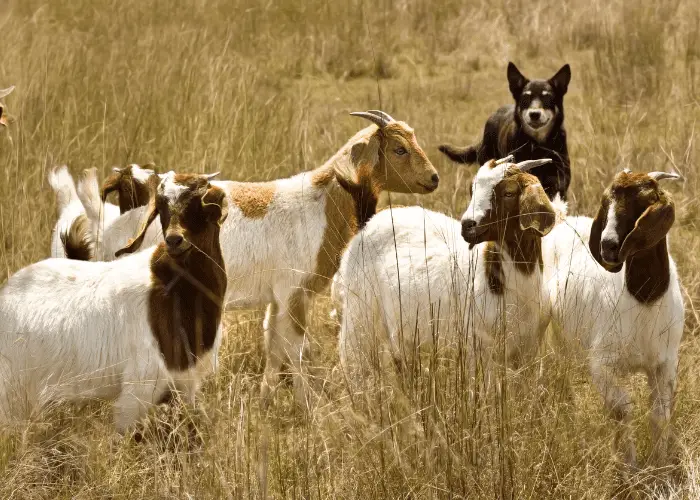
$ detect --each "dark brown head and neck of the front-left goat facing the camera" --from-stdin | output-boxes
[117,172,228,370]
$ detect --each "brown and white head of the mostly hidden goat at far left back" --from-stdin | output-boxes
[100,163,158,214]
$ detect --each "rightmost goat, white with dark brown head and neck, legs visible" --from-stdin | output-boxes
[544,169,684,465]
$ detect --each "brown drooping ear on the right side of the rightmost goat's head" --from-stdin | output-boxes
[620,195,676,262]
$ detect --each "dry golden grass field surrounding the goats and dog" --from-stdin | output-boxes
[0,0,700,499]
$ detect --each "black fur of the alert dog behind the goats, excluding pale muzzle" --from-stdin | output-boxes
[439,62,571,200]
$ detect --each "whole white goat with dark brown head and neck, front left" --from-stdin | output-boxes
[0,172,227,433]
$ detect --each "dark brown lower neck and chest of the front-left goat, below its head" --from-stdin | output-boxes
[148,242,226,371]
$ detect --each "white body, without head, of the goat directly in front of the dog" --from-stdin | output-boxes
[333,207,549,374]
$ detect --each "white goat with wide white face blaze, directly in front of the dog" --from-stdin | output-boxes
[333,156,555,380]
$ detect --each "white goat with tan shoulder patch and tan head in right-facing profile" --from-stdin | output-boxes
[117,110,439,406]
